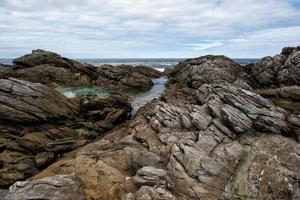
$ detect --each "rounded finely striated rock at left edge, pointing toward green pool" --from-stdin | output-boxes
[0,79,79,123]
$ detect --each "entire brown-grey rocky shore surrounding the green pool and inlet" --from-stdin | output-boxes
[0,47,300,200]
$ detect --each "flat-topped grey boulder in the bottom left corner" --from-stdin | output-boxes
[4,174,86,200]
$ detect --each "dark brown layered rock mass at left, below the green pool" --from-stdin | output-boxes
[0,79,131,186]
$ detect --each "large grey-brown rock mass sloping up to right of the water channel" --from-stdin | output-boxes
[25,48,300,200]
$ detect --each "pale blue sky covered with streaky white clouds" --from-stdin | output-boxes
[0,0,300,58]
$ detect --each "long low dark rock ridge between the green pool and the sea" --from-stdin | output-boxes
[0,49,164,89]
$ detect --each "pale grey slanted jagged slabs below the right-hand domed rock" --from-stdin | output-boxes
[198,84,290,133]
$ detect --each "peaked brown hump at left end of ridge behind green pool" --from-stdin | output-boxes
[12,49,98,87]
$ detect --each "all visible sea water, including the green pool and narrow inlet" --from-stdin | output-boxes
[0,58,258,114]
